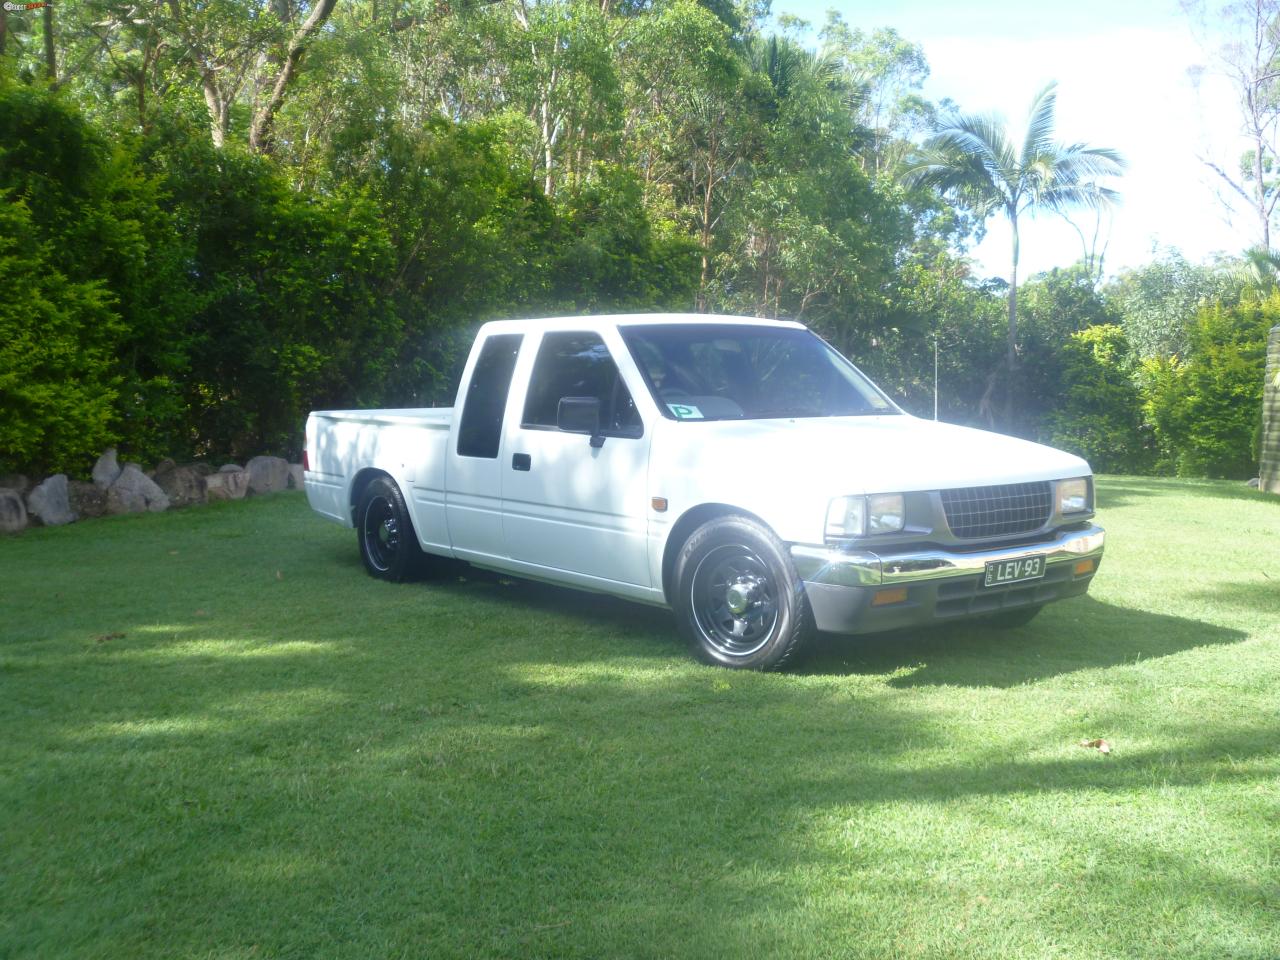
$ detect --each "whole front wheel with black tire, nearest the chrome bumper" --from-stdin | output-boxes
[672,516,814,669]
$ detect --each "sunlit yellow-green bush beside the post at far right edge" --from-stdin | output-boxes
[1142,294,1280,479]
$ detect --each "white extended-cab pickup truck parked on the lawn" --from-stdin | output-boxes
[305,314,1103,669]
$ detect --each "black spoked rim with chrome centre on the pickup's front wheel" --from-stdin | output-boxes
[690,544,778,658]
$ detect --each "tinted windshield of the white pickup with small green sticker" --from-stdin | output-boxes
[621,324,899,420]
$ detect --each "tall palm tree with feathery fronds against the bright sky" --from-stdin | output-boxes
[904,83,1125,424]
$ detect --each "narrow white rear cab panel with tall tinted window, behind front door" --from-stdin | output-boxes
[444,333,525,559]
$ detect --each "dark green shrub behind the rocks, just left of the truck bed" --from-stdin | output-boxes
[155,141,398,456]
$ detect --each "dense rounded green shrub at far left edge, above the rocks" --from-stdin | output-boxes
[0,83,188,472]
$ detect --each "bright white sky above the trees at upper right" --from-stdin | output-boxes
[773,0,1257,278]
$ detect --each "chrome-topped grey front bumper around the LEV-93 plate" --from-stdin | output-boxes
[791,525,1106,634]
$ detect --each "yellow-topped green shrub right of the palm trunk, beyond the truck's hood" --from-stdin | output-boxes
[1044,324,1153,474]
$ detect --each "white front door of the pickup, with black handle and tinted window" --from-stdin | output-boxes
[502,330,652,588]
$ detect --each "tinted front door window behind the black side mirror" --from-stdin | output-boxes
[521,333,644,438]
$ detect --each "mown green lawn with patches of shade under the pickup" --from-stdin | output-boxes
[0,479,1280,960]
